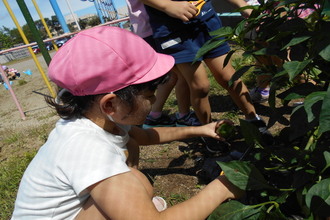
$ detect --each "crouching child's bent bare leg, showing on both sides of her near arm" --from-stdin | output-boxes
[75,168,154,220]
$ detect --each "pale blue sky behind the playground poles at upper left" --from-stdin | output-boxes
[0,0,126,29]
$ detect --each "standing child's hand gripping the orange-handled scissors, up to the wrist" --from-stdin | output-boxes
[164,1,198,22]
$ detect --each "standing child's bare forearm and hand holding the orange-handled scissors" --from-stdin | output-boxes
[140,0,197,21]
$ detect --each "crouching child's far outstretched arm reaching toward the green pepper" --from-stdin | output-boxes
[129,120,232,145]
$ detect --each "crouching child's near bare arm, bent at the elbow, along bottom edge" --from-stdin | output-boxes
[88,169,242,220]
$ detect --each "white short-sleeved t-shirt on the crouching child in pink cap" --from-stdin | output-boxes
[12,118,131,220]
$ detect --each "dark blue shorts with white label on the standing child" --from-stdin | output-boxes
[147,1,230,64]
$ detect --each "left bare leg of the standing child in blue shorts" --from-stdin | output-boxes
[176,62,211,124]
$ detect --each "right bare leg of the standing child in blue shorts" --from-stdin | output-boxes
[205,55,256,119]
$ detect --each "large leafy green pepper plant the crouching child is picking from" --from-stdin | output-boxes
[196,0,330,220]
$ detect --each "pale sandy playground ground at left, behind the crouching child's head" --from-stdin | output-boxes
[0,52,58,161]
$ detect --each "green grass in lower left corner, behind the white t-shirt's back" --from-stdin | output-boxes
[0,151,36,219]
